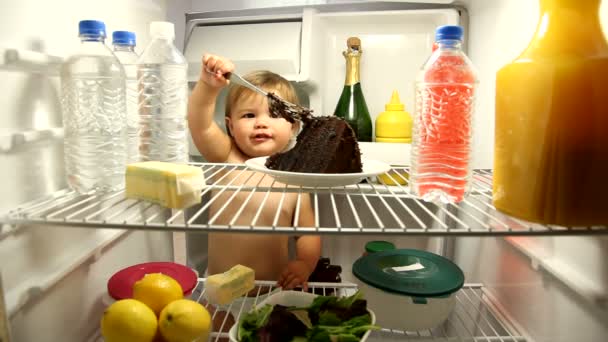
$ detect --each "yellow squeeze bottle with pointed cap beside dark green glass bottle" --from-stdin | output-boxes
[376,90,412,185]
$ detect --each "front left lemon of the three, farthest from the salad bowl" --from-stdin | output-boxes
[101,299,158,342]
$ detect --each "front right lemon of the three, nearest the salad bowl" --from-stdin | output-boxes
[158,299,211,342]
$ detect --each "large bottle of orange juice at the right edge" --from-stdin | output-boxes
[493,0,608,226]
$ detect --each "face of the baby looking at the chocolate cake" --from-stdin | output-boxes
[226,89,297,158]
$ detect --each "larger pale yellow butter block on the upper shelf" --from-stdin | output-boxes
[126,161,205,208]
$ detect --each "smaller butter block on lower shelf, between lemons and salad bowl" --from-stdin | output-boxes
[205,265,255,305]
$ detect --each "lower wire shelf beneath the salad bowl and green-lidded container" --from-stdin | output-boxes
[192,278,526,342]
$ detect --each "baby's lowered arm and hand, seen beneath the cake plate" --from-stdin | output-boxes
[277,195,321,290]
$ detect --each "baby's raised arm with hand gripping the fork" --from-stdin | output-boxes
[188,55,234,163]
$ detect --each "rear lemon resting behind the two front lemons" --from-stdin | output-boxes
[133,273,184,316]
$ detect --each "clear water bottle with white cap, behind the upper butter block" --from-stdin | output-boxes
[137,22,188,163]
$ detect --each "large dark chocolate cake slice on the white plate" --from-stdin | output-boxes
[266,116,362,173]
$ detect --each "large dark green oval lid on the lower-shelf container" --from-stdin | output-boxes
[353,249,464,297]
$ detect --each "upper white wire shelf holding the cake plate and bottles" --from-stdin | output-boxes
[4,163,608,235]
